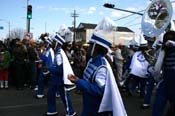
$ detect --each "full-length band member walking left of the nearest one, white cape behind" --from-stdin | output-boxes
[45,34,76,116]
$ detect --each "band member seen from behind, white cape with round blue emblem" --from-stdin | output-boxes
[129,34,149,97]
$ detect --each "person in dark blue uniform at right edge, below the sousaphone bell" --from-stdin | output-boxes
[152,31,175,116]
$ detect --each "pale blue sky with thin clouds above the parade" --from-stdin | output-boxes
[0,0,175,39]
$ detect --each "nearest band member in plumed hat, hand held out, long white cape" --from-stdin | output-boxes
[68,33,127,116]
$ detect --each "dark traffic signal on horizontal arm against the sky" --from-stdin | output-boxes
[103,3,143,15]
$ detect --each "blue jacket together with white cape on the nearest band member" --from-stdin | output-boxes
[76,55,127,116]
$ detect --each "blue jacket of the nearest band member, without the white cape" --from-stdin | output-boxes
[77,55,107,112]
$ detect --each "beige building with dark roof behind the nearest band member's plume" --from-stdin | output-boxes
[76,23,134,45]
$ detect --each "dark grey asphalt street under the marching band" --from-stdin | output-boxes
[0,86,154,116]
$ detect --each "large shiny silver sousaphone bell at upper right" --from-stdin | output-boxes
[141,0,173,38]
